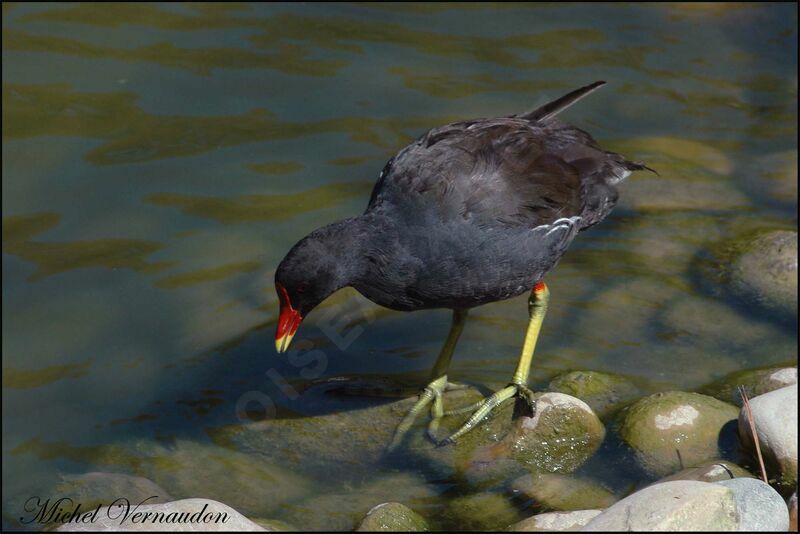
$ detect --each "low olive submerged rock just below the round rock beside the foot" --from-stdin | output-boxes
[511,473,617,512]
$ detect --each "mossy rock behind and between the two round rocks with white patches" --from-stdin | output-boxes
[547,371,641,419]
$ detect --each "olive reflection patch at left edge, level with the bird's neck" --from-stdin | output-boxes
[3,213,173,282]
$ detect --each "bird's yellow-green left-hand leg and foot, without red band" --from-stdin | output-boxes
[389,310,467,451]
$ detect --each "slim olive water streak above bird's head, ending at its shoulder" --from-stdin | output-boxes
[145,181,373,224]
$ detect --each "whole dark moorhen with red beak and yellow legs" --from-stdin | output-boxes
[275,81,649,446]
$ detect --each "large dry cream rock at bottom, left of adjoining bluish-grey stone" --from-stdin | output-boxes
[582,480,738,532]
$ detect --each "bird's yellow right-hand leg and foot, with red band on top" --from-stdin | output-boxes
[441,282,550,445]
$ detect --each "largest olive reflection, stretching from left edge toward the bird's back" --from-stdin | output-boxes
[3,84,454,164]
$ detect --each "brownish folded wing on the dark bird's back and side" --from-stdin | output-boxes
[367,117,584,228]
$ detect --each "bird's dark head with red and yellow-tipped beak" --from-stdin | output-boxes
[275,225,362,353]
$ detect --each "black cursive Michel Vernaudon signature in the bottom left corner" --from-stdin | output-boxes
[19,495,228,525]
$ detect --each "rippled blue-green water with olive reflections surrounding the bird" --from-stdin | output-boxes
[3,3,797,527]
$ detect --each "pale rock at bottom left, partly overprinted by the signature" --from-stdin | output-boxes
[57,499,264,532]
